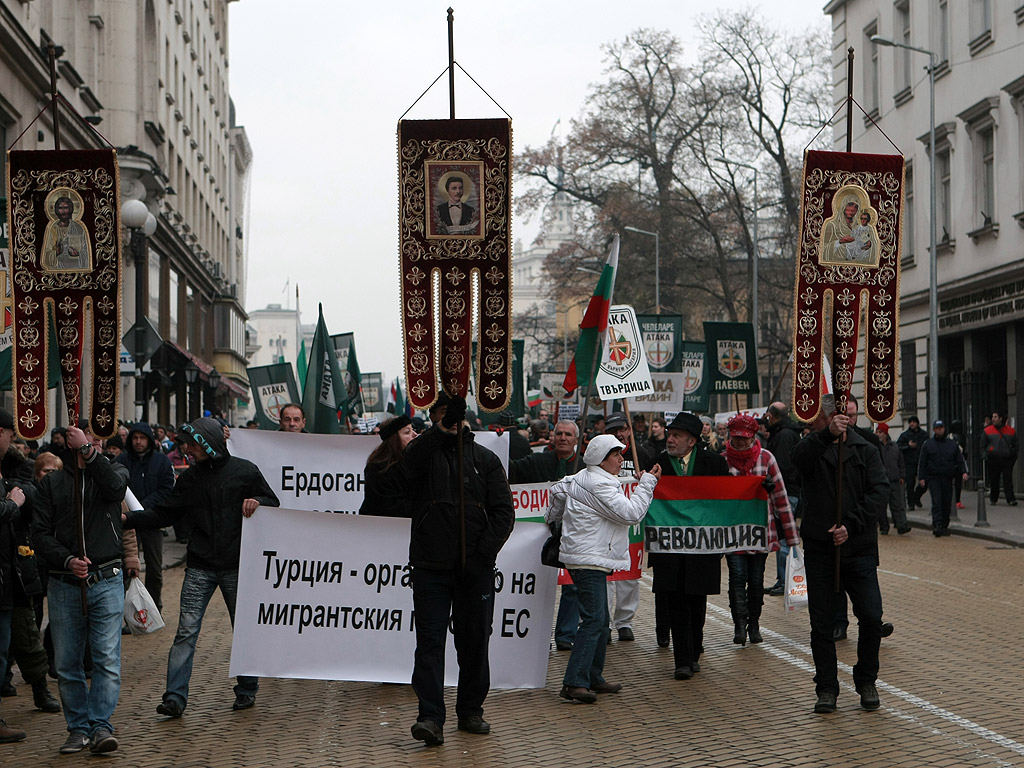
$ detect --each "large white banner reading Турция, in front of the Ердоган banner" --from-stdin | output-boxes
[228,507,556,688]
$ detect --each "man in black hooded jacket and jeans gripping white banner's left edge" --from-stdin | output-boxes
[125,418,280,718]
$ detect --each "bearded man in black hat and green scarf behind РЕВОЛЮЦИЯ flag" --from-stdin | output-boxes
[647,412,729,680]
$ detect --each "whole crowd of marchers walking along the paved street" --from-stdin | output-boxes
[0,394,1018,754]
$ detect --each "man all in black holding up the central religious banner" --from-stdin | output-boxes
[406,396,515,745]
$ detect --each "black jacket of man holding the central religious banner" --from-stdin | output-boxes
[404,426,515,570]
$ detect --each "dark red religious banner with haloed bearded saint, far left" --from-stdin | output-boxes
[7,150,121,439]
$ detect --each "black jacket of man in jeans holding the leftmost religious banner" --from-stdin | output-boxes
[32,453,128,572]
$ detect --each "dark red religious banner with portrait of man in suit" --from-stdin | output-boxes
[398,119,512,411]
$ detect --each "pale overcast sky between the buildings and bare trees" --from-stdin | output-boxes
[228,0,828,385]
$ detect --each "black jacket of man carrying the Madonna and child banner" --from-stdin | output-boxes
[793,427,889,562]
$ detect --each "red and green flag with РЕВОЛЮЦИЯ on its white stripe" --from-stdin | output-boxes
[644,475,769,554]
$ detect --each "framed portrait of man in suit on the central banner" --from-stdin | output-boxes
[424,160,483,240]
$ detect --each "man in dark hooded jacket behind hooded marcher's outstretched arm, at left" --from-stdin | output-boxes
[116,422,174,610]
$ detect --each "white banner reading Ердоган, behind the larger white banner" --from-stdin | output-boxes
[227,429,509,515]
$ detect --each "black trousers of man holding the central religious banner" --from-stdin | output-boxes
[413,565,495,725]
